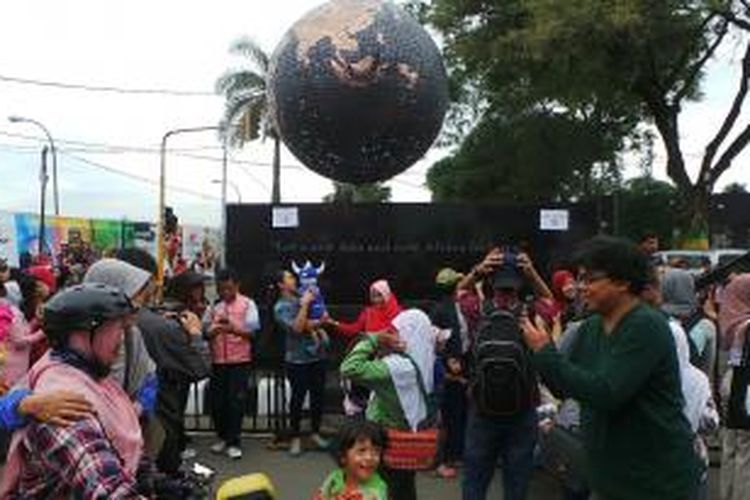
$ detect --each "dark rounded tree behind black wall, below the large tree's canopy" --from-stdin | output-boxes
[427,110,622,202]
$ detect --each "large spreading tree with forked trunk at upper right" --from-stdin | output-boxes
[427,0,750,245]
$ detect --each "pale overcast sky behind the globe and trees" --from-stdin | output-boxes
[0,0,750,228]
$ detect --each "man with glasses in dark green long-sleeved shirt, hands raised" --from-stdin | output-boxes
[522,237,697,500]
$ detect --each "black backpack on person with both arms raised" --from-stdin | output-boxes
[471,307,537,417]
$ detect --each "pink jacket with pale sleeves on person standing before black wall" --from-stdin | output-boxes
[210,295,260,365]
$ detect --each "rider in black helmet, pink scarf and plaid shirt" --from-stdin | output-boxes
[0,284,151,499]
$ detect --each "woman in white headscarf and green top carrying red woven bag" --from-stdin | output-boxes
[340,309,438,500]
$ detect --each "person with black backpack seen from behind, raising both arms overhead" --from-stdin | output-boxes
[460,248,552,500]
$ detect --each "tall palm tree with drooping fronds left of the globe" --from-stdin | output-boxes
[216,37,281,204]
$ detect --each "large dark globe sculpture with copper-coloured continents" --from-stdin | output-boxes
[268,0,448,184]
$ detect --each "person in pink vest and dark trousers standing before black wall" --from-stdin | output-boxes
[206,269,260,460]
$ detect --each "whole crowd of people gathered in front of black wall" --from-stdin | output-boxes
[0,232,750,500]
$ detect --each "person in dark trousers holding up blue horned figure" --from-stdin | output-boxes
[273,271,329,457]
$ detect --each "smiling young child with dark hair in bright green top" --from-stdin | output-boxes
[313,421,388,500]
